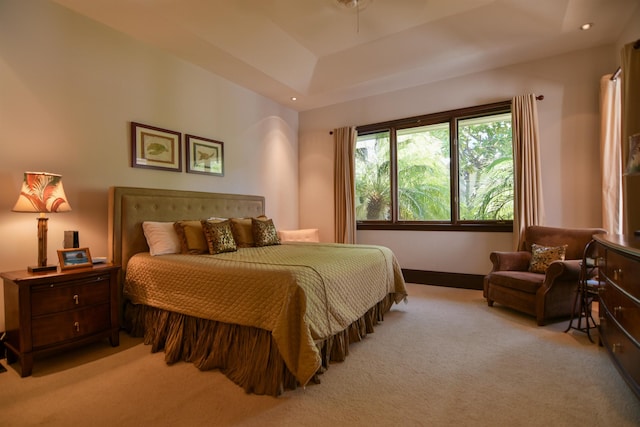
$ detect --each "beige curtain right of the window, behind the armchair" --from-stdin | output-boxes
[511,94,544,249]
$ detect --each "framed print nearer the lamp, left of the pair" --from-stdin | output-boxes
[131,122,182,172]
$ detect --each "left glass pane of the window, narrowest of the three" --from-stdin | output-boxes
[355,131,391,221]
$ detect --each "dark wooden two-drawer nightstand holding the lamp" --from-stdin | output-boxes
[0,264,120,377]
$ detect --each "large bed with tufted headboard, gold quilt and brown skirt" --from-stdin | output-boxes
[109,187,407,396]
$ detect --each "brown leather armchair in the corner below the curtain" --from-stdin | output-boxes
[484,225,606,326]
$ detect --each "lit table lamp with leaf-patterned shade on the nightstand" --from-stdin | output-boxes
[12,172,71,272]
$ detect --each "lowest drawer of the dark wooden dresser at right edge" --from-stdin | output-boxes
[599,310,640,393]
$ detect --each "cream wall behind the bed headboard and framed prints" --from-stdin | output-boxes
[0,0,298,331]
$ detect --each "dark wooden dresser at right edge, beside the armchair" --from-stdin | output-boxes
[594,235,640,398]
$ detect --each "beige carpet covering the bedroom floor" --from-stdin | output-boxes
[0,285,640,427]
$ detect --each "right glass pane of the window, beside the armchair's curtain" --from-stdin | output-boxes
[458,113,513,221]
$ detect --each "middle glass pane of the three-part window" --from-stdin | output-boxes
[397,123,451,221]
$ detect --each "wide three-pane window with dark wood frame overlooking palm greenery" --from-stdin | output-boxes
[355,101,514,231]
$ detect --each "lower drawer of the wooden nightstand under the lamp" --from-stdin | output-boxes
[31,301,111,349]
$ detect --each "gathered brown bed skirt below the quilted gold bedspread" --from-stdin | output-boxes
[124,293,396,396]
